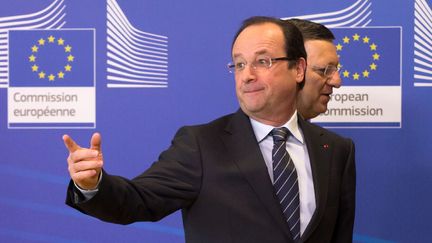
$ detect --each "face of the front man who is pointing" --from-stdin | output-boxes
[232,23,304,125]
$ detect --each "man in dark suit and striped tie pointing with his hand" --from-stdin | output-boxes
[63,17,355,243]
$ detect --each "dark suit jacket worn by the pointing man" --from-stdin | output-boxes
[67,110,355,243]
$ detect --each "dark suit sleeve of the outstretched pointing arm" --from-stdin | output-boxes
[66,127,202,224]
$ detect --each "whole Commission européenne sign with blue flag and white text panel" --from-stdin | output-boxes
[8,29,96,128]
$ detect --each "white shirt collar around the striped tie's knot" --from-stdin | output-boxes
[249,110,304,144]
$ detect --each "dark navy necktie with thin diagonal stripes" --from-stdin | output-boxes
[271,127,300,242]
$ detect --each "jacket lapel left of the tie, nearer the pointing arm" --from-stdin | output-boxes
[222,110,291,239]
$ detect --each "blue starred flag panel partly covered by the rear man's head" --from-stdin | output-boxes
[332,27,401,86]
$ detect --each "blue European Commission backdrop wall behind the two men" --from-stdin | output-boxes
[0,0,432,242]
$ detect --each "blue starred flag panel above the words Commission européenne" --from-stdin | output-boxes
[9,29,95,87]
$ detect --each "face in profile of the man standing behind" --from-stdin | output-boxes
[297,40,342,119]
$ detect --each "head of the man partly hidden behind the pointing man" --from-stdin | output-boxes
[286,19,342,120]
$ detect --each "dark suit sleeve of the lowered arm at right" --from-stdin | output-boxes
[332,139,356,243]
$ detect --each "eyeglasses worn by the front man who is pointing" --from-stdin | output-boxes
[227,56,292,73]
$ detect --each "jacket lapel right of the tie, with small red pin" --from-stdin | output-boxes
[299,117,333,241]
